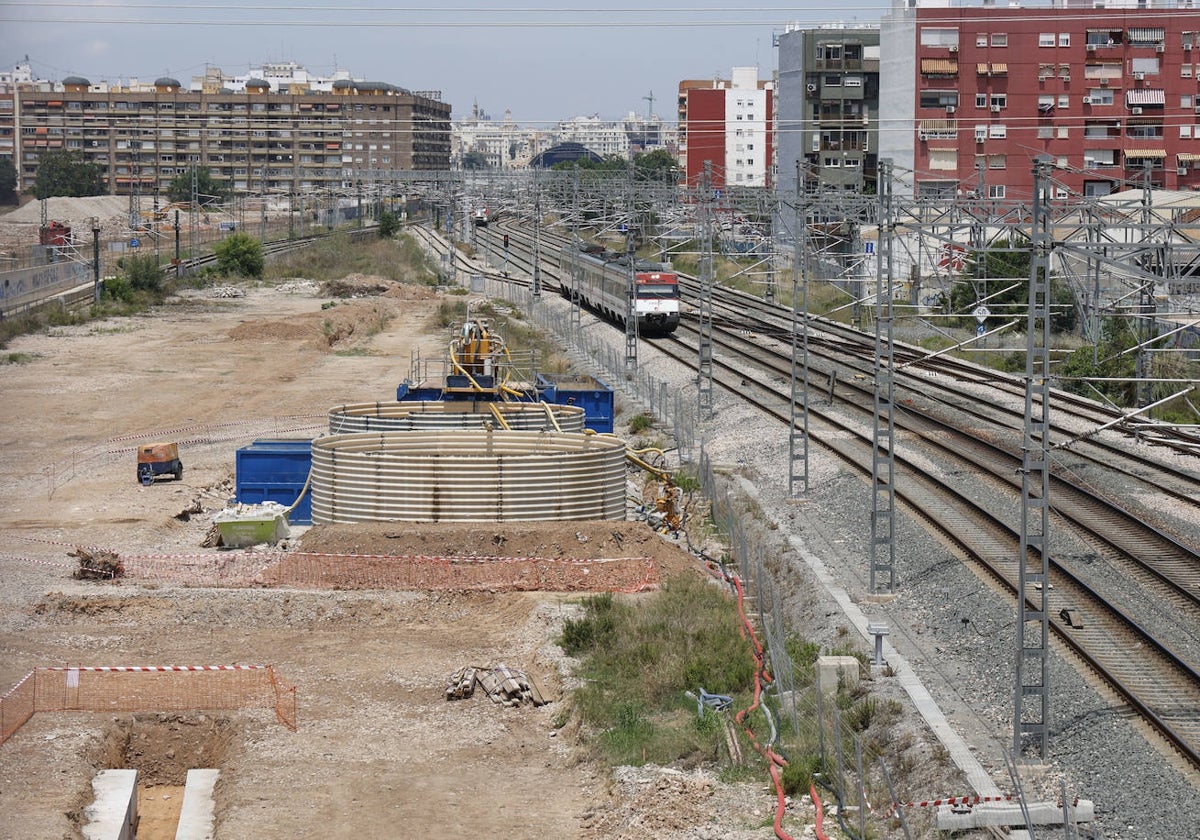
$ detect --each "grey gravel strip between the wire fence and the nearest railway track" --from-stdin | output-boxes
[532,290,1200,840]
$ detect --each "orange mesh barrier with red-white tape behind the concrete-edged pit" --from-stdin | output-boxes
[0,665,296,744]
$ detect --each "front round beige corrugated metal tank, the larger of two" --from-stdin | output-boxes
[311,431,625,524]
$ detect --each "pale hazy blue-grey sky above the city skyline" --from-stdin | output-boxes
[0,0,887,125]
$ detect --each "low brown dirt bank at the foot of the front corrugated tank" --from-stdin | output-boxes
[298,522,700,576]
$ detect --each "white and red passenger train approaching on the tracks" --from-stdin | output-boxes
[559,246,679,336]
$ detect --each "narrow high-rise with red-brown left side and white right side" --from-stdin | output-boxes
[678,67,775,188]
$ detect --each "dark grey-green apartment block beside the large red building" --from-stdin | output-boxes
[775,25,880,194]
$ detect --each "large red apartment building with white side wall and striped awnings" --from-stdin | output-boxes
[880,0,1200,200]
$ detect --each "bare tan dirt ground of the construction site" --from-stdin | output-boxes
[0,281,787,840]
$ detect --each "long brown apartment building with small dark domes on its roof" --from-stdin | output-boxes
[0,66,450,194]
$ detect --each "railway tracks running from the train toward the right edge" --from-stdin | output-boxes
[424,219,1200,768]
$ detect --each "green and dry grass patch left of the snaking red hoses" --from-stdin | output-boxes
[560,575,754,764]
